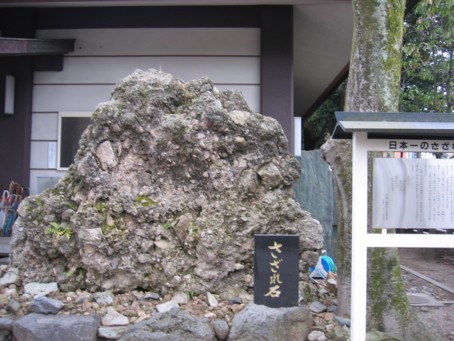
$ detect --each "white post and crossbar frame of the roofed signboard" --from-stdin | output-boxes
[350,131,454,341]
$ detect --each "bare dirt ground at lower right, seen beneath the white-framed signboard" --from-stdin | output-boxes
[399,249,454,340]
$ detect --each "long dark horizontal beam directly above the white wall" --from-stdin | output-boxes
[33,6,260,30]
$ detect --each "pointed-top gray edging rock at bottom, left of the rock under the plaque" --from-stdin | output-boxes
[120,308,217,341]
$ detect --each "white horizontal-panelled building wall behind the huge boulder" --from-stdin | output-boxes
[30,28,260,194]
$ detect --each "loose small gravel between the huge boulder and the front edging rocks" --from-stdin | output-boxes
[0,258,350,341]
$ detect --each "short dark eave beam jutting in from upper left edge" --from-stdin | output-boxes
[0,37,75,57]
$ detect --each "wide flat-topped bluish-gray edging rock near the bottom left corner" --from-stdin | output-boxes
[13,314,100,341]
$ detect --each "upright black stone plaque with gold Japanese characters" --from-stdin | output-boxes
[254,234,299,308]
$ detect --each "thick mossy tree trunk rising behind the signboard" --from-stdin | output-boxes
[322,0,442,341]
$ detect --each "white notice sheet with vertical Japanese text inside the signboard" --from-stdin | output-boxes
[372,158,454,229]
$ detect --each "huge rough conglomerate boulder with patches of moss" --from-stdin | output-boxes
[12,70,323,294]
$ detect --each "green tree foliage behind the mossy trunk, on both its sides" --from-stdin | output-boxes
[304,0,454,150]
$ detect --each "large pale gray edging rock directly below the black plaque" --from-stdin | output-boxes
[227,303,312,341]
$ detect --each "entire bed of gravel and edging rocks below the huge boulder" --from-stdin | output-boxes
[0,266,350,341]
